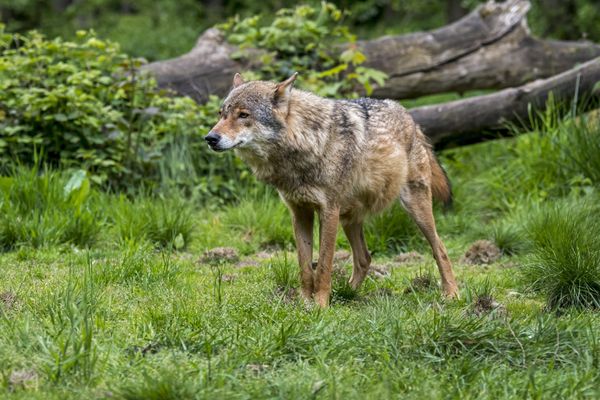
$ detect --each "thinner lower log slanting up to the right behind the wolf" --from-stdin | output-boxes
[409,57,600,148]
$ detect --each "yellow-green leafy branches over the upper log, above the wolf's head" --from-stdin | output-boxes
[218,2,387,97]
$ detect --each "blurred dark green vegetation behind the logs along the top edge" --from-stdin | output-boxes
[0,0,600,60]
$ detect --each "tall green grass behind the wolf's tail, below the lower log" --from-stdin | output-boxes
[444,97,600,219]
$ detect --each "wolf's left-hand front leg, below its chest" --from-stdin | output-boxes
[289,205,315,301]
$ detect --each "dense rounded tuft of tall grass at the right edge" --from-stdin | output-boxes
[523,202,600,309]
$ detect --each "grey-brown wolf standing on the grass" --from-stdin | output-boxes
[205,74,458,307]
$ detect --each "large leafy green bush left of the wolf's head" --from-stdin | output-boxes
[0,26,243,199]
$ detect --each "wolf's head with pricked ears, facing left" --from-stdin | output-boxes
[204,73,297,151]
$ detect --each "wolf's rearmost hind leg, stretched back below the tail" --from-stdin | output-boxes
[400,180,458,297]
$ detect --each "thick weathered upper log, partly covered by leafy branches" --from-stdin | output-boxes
[144,0,600,102]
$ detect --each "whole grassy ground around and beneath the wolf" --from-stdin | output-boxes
[0,111,600,399]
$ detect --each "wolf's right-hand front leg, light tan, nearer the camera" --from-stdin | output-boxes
[315,206,340,307]
